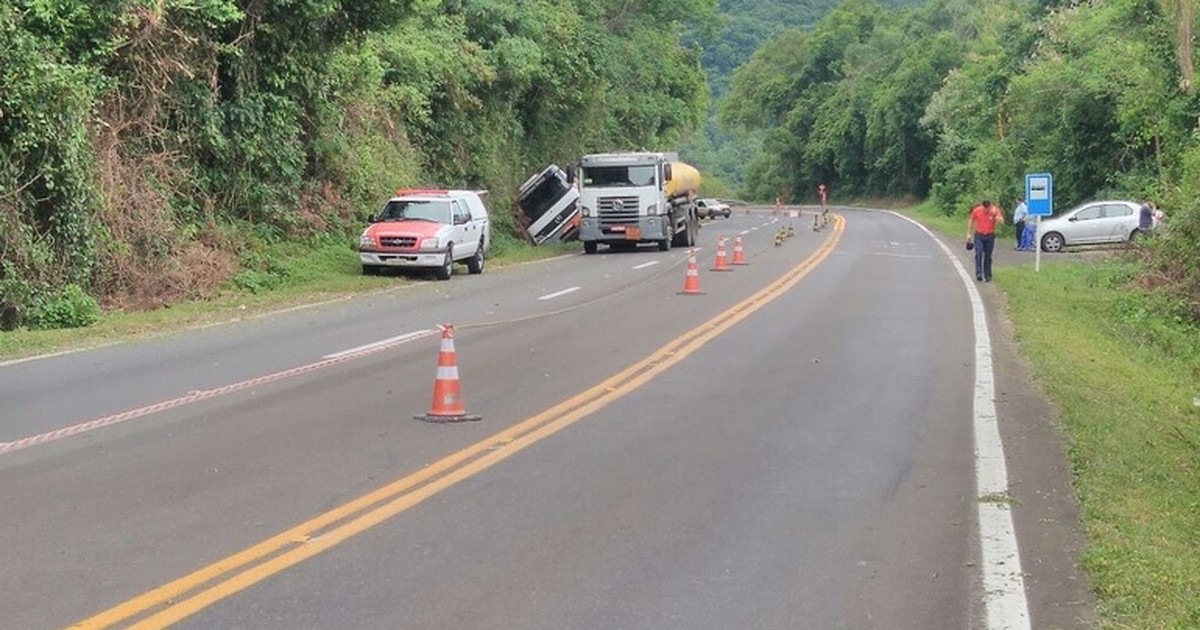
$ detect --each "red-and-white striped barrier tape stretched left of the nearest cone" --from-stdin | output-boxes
[0,330,438,456]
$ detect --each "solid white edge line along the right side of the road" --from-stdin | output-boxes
[890,212,1031,630]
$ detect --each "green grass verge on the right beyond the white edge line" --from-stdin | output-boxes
[996,260,1200,629]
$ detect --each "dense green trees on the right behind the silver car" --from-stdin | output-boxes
[721,0,1200,318]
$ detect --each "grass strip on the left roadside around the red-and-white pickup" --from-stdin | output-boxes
[0,239,581,359]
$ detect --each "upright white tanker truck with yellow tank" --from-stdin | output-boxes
[580,151,700,253]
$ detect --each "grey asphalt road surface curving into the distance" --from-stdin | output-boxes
[0,210,1086,629]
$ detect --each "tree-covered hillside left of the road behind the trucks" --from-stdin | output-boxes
[0,0,715,329]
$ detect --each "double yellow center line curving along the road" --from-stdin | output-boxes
[72,215,845,629]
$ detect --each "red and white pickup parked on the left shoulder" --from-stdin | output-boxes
[359,190,492,280]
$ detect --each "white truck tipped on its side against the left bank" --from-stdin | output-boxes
[517,164,580,245]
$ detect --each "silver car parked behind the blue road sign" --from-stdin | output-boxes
[1037,202,1141,252]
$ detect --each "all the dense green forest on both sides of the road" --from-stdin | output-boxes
[0,0,1200,329]
